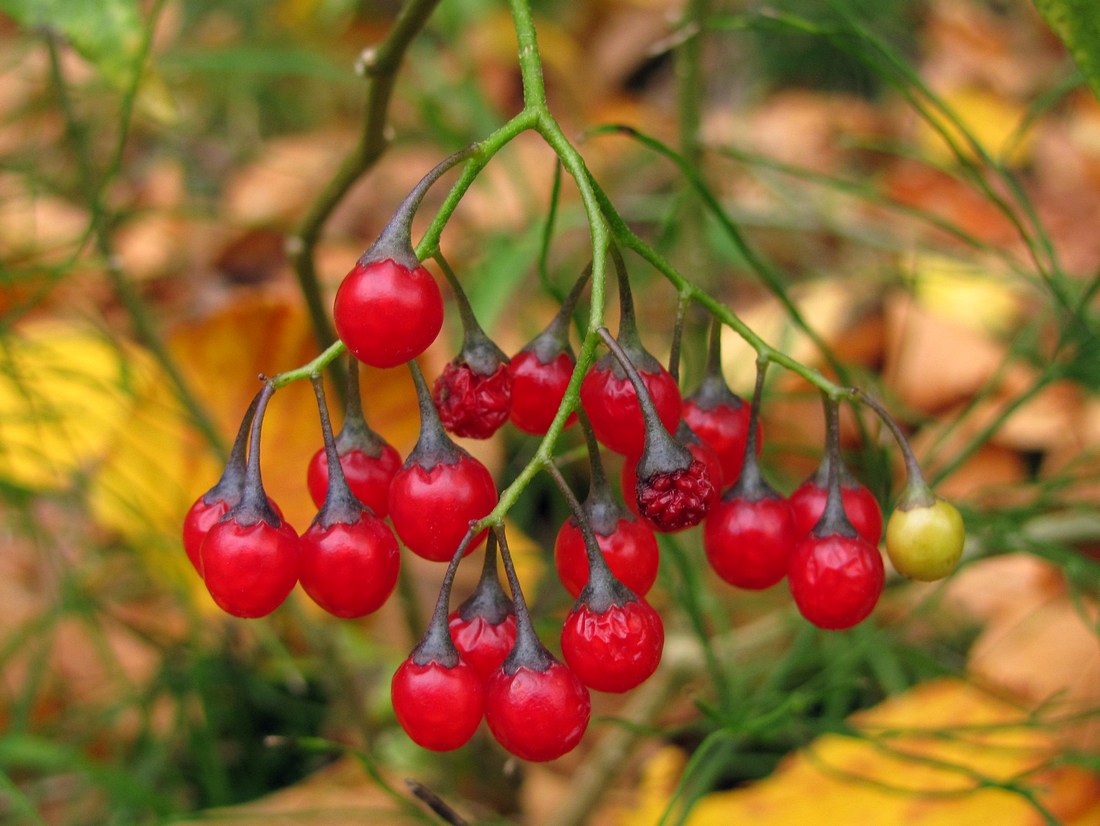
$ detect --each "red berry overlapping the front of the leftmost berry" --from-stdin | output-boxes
[201,516,300,618]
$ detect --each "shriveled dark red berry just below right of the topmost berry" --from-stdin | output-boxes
[431,361,513,439]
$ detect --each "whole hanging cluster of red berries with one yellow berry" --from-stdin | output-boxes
[184,153,964,760]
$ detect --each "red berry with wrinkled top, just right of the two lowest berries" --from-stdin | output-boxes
[561,599,664,694]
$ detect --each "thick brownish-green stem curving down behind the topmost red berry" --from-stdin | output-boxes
[287,0,439,348]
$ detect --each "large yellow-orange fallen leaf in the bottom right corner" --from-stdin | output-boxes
[619,679,1100,826]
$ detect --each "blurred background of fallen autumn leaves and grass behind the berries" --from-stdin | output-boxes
[0,0,1100,826]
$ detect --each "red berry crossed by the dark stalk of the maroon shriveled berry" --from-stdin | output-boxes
[581,356,681,458]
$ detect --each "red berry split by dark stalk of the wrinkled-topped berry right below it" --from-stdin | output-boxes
[553,517,660,598]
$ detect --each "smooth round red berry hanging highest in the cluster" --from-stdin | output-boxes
[332,258,443,367]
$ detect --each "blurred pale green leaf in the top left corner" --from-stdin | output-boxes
[0,0,145,89]
